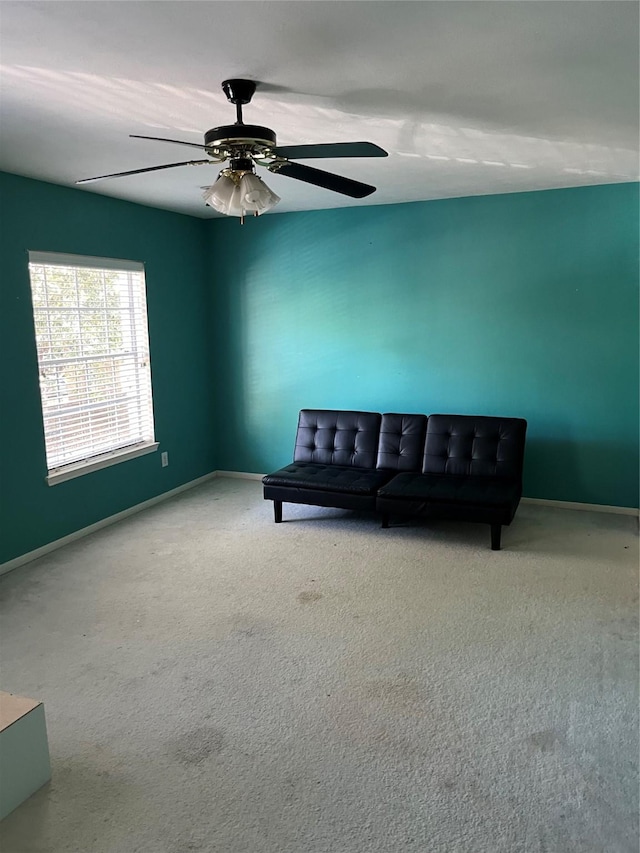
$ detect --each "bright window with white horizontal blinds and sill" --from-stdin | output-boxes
[29,252,158,485]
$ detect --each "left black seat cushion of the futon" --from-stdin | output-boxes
[262,462,394,495]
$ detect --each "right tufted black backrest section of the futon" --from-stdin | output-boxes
[422,415,527,481]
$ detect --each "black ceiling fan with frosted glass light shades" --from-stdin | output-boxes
[76,79,387,221]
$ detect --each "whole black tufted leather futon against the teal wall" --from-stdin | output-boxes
[262,409,527,550]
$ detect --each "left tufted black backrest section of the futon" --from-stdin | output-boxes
[293,409,381,468]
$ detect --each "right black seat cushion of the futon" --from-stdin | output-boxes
[378,473,520,508]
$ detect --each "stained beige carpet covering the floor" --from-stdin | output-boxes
[0,479,638,853]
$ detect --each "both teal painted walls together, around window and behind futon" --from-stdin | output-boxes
[0,173,638,562]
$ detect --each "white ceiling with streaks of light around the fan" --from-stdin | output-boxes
[0,0,639,217]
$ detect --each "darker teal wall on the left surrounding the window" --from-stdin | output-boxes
[0,173,215,562]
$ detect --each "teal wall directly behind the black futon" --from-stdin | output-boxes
[208,184,638,507]
